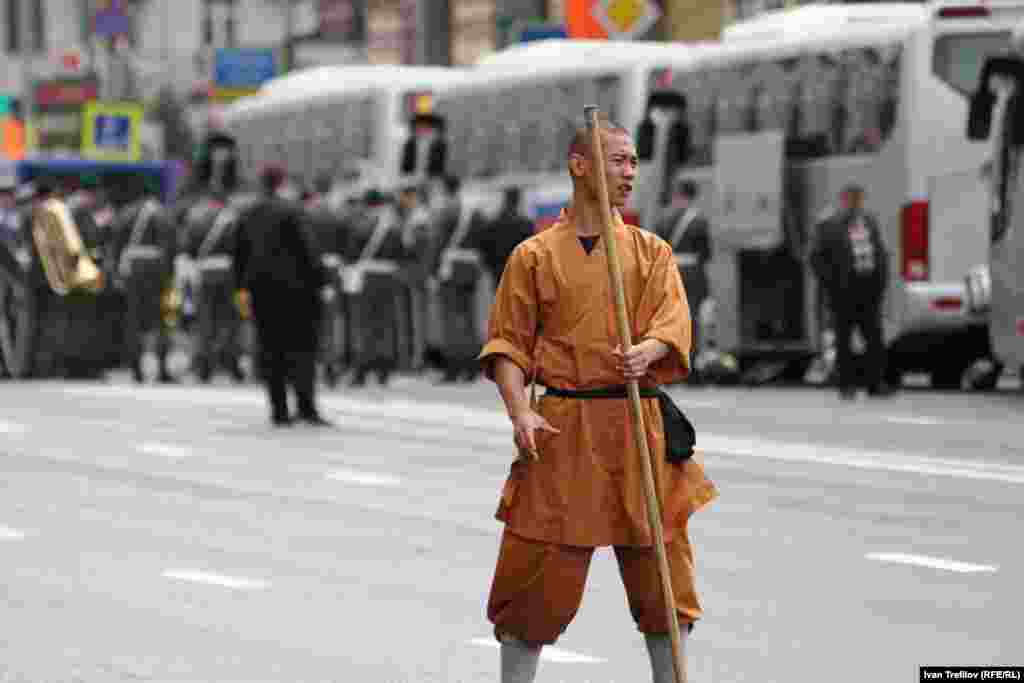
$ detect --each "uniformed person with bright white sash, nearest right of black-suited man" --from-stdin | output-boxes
[342,189,406,386]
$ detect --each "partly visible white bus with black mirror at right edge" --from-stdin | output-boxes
[968,46,1024,384]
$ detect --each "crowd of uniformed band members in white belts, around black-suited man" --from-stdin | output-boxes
[3,168,534,393]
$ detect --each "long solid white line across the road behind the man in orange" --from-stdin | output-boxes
[63,386,1024,484]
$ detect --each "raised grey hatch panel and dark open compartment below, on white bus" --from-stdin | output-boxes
[709,130,807,357]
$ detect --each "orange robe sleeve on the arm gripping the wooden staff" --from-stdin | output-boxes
[636,244,692,384]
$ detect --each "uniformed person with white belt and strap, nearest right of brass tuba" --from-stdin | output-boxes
[113,178,177,383]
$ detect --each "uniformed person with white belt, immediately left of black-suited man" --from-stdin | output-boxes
[184,192,245,383]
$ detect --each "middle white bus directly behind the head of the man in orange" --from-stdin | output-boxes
[434,40,712,228]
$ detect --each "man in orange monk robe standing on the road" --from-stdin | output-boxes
[479,122,717,683]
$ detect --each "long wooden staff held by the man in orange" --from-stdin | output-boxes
[584,104,686,683]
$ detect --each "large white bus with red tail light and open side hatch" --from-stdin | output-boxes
[638,0,1024,388]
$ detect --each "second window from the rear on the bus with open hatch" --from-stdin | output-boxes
[790,54,843,159]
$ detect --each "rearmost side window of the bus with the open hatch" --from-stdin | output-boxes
[843,47,900,154]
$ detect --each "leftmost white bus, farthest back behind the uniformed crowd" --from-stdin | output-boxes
[224,66,463,198]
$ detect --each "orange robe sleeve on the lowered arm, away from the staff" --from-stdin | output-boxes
[477,243,538,380]
